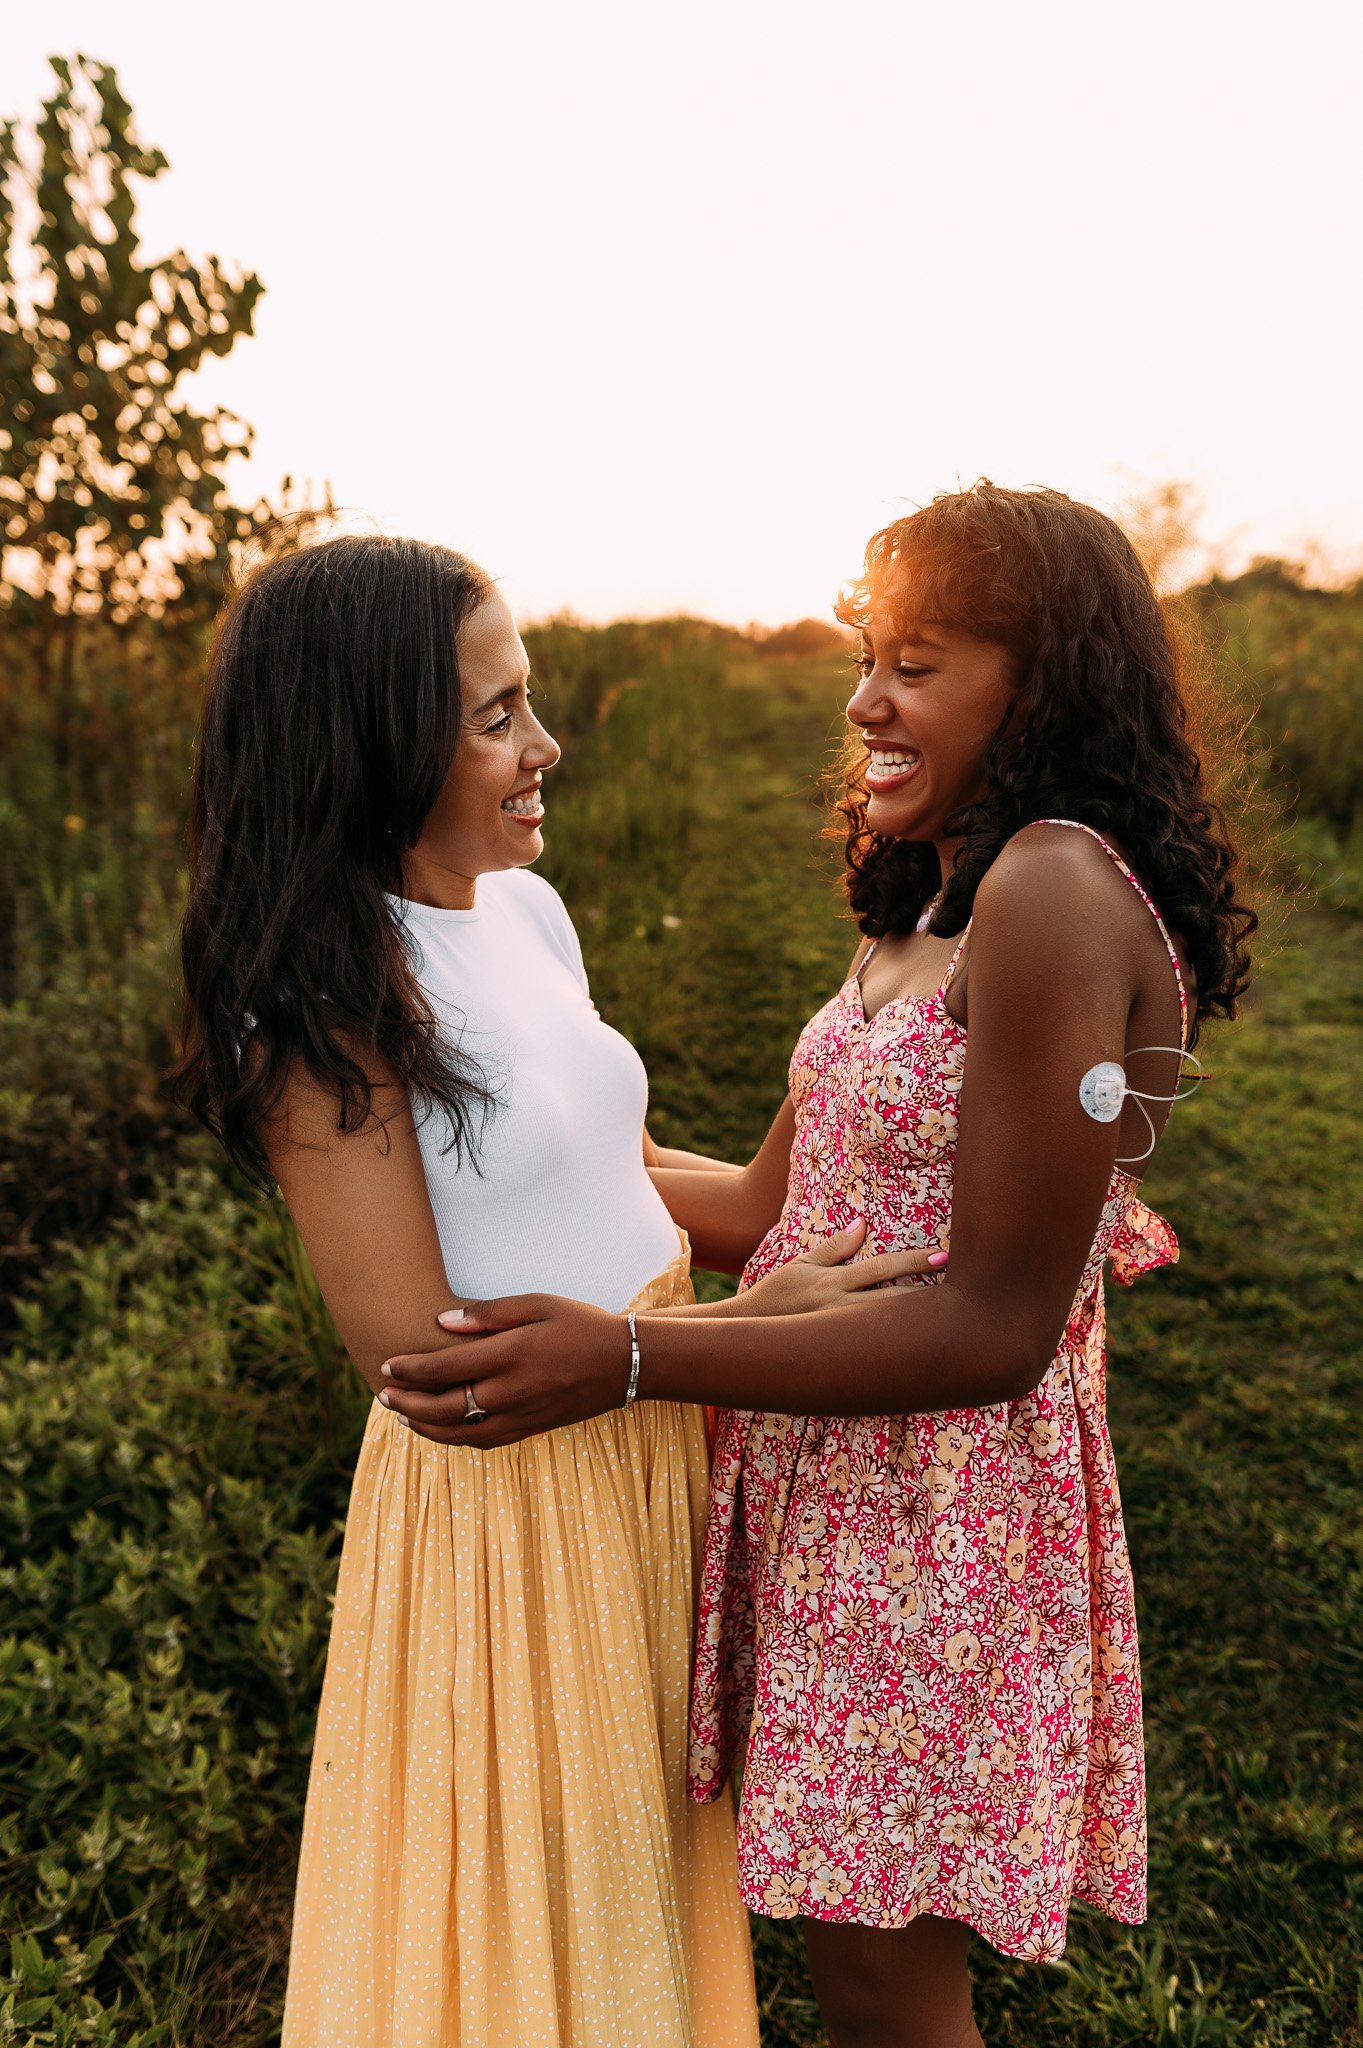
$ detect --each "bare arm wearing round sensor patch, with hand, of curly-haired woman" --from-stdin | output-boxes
[382,829,1173,1444]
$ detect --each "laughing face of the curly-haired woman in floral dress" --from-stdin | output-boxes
[847,618,1013,848]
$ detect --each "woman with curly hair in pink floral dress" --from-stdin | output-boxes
[378,483,1255,2048]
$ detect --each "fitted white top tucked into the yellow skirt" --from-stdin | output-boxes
[389,868,677,1311]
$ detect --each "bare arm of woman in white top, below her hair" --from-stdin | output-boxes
[264,1069,458,1393]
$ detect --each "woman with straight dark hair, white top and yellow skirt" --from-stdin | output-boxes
[178,539,757,2048]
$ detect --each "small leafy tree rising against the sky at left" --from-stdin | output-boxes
[0,55,282,758]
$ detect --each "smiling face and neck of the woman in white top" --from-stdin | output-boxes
[403,590,561,909]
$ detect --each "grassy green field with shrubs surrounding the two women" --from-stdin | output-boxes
[0,585,1363,2048]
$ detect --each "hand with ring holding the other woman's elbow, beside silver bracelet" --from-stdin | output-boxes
[379,1294,630,1450]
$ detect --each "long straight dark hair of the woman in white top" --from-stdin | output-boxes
[172,537,493,1188]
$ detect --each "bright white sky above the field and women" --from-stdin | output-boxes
[0,0,1363,623]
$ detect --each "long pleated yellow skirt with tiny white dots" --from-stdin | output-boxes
[282,1257,757,2048]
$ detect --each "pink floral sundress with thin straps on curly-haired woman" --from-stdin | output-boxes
[692,819,1187,1960]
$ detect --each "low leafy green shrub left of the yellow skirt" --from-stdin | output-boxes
[0,1167,366,2044]
